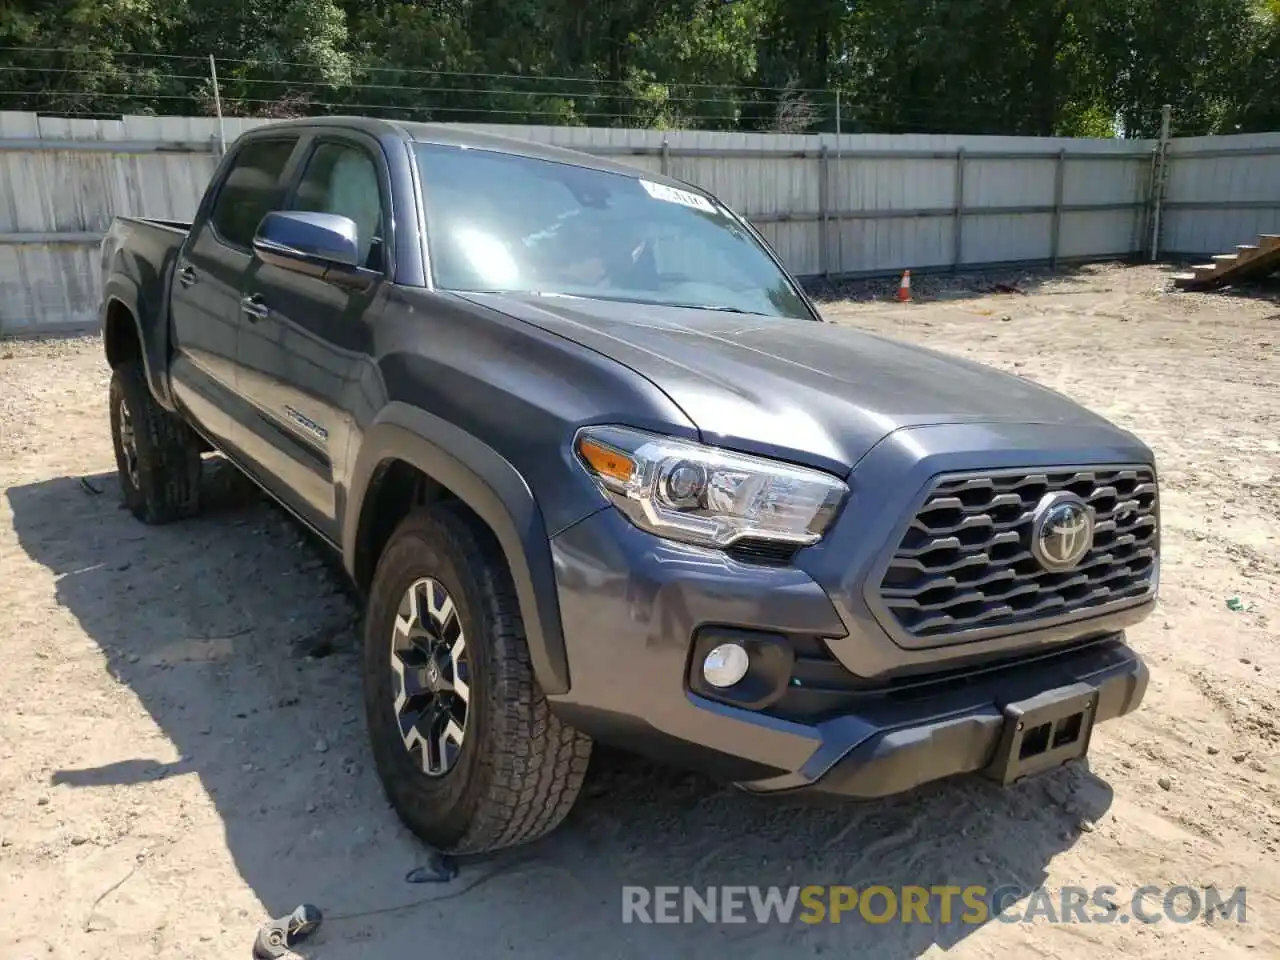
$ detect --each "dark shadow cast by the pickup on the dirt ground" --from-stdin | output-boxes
[6,466,1111,959]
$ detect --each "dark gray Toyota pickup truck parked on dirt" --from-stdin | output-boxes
[101,118,1158,851]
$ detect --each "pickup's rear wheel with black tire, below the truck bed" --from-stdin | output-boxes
[109,360,201,524]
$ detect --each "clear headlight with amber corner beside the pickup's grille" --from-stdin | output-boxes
[573,426,849,547]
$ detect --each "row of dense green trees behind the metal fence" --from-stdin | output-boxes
[0,0,1280,137]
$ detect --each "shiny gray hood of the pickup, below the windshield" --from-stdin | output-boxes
[462,293,1121,472]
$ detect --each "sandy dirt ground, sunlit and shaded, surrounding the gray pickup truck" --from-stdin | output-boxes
[0,266,1280,960]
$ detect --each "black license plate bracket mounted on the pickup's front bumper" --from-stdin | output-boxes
[983,684,1098,786]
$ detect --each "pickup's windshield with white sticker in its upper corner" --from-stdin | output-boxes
[416,143,813,320]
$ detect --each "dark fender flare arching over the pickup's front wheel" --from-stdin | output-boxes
[342,402,570,695]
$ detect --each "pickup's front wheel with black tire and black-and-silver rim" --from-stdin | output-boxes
[364,504,591,852]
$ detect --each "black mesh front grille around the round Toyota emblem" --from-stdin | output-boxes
[879,467,1157,639]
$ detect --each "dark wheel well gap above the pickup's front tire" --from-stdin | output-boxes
[352,458,500,594]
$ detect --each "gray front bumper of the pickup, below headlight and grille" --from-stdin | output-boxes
[549,509,1149,796]
